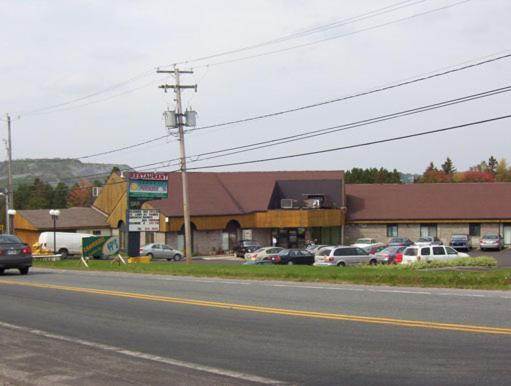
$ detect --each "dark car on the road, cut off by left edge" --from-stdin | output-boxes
[0,235,32,275]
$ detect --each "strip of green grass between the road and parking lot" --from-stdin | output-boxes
[34,260,511,290]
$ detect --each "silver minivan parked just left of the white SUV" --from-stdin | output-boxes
[314,246,378,267]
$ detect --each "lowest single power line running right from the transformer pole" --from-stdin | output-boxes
[188,114,511,170]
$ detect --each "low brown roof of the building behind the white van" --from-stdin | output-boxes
[16,207,110,230]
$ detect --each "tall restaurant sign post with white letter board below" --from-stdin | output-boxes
[126,172,169,257]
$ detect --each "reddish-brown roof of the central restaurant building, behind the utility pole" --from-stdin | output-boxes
[150,171,344,217]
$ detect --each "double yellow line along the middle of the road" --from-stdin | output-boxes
[0,280,511,335]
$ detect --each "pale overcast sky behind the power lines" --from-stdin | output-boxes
[0,0,511,173]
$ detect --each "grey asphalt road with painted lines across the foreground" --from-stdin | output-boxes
[0,269,511,385]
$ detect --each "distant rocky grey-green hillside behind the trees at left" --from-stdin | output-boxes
[0,158,130,188]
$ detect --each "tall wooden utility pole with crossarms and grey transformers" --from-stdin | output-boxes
[156,65,197,264]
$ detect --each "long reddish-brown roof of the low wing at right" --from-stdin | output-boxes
[346,182,511,221]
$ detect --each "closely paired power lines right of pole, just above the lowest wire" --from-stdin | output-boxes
[184,85,511,162]
